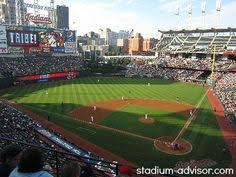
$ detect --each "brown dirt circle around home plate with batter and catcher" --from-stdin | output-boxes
[154,136,192,155]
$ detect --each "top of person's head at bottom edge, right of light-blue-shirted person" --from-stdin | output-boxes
[61,162,81,177]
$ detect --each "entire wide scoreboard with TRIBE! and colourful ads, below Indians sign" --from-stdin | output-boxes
[4,27,76,53]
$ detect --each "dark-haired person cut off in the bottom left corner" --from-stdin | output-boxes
[0,145,21,177]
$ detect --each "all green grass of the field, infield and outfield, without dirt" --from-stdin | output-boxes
[1,78,231,174]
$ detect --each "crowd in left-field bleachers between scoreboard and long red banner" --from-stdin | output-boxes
[0,56,83,77]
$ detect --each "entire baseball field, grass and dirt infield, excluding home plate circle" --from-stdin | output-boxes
[1,77,231,171]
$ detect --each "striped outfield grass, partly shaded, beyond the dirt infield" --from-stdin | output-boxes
[3,78,205,114]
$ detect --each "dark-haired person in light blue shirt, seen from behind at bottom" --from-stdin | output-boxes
[9,148,52,177]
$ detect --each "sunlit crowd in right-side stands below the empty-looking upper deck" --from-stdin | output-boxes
[126,58,236,125]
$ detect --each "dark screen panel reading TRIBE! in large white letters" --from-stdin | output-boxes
[7,31,38,46]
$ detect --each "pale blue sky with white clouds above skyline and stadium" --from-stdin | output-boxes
[25,0,236,38]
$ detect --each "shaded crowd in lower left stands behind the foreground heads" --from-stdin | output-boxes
[0,103,65,174]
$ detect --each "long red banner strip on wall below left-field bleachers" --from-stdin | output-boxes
[18,72,79,81]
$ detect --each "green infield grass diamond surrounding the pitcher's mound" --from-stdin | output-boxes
[98,105,188,139]
